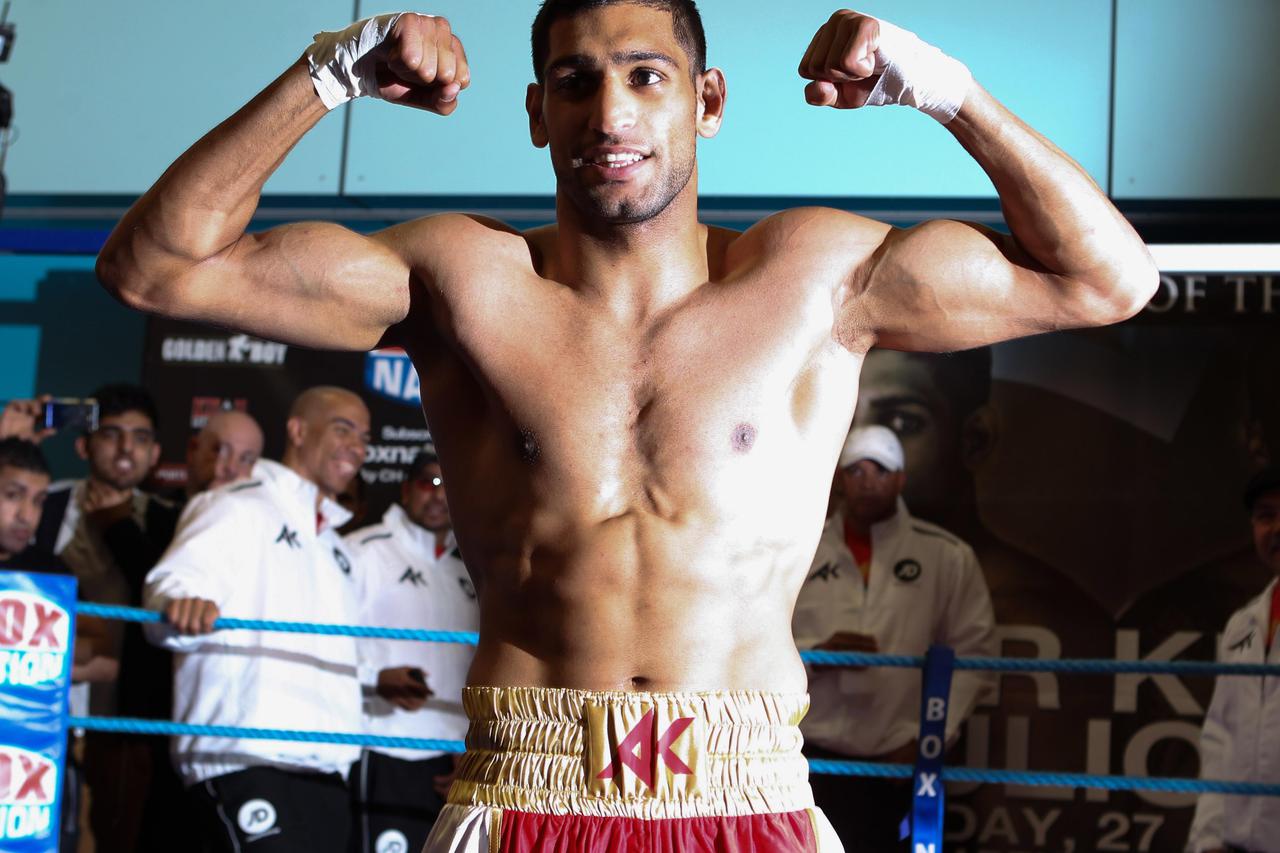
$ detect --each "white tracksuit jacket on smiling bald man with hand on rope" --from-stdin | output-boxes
[146,460,362,785]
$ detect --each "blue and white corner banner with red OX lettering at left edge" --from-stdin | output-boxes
[0,571,76,853]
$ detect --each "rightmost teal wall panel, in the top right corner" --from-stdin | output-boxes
[1112,0,1280,199]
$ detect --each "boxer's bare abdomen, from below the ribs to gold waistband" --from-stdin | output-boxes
[470,504,805,693]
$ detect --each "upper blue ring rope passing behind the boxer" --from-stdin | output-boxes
[76,602,1280,675]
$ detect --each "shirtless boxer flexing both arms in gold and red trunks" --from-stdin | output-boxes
[97,0,1157,850]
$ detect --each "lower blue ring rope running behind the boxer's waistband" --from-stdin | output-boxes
[67,717,1280,797]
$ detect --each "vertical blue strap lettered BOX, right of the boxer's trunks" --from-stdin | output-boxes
[902,646,956,853]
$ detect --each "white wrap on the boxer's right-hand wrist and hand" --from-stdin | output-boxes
[867,20,973,124]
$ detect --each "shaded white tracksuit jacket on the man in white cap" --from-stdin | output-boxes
[791,498,996,757]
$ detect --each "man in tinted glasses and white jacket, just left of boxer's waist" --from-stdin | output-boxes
[346,446,480,853]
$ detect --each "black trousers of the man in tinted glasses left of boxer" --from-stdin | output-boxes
[351,749,453,853]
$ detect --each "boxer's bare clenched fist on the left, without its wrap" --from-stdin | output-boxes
[375,12,471,115]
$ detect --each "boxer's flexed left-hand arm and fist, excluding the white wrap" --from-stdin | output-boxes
[97,14,470,348]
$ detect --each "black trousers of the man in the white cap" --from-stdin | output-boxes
[804,745,911,853]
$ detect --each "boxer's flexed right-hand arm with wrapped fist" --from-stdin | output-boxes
[800,13,1158,350]
